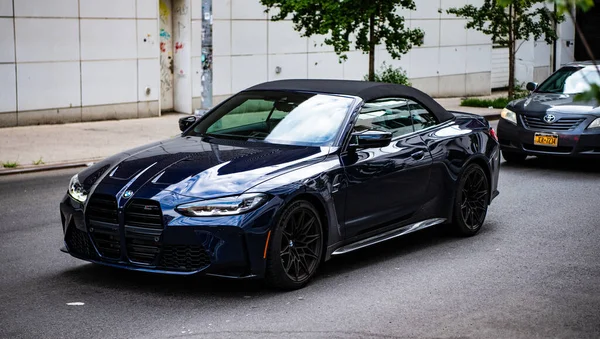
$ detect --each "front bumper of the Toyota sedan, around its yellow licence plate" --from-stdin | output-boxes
[498,119,600,158]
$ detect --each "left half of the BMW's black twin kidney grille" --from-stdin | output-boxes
[86,194,121,259]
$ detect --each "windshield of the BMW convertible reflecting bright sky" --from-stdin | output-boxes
[187,91,354,146]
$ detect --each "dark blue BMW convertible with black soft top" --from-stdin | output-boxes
[60,80,500,289]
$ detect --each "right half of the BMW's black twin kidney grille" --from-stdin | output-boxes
[125,199,163,265]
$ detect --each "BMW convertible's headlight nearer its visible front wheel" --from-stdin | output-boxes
[175,193,268,217]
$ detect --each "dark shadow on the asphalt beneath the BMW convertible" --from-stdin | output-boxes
[55,222,495,299]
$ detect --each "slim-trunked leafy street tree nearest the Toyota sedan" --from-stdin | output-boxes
[446,0,563,98]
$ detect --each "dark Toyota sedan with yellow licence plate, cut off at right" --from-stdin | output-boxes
[498,62,600,163]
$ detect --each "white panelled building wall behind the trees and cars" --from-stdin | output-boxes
[0,0,575,127]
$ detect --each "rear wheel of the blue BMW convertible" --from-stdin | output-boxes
[452,164,490,236]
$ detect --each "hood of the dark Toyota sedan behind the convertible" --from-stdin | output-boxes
[508,93,600,115]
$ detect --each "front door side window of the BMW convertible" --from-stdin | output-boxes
[354,98,414,137]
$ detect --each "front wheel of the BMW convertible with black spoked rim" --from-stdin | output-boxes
[265,200,323,290]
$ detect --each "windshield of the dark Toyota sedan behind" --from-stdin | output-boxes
[536,67,600,94]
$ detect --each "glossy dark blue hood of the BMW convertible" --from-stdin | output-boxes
[79,137,329,199]
